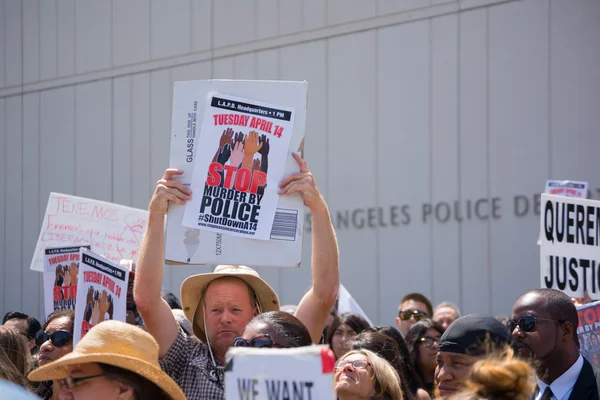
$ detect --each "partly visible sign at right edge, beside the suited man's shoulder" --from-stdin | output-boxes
[577,301,600,368]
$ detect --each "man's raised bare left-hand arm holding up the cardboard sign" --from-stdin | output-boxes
[133,169,190,358]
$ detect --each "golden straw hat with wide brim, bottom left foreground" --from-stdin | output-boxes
[28,320,185,400]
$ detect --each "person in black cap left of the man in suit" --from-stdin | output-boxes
[435,314,513,397]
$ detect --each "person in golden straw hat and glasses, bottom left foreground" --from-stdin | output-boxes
[28,320,185,400]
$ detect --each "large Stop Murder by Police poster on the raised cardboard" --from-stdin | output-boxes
[183,94,294,240]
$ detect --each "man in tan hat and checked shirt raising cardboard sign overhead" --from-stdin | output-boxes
[134,153,339,400]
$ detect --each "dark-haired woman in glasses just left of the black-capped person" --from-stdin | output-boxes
[404,318,444,396]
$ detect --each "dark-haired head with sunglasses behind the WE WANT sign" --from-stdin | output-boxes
[233,311,312,348]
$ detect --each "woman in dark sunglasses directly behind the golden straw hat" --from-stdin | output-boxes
[35,310,75,400]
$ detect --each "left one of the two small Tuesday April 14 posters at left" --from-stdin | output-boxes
[44,246,90,315]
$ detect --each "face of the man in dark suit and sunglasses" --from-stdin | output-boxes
[511,293,561,360]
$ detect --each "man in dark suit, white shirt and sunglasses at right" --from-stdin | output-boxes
[508,289,600,400]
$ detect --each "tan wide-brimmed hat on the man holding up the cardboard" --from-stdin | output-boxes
[181,265,279,343]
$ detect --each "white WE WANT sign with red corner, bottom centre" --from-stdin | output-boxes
[225,346,336,400]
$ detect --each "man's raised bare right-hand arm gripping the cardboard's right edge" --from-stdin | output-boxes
[280,154,340,343]
